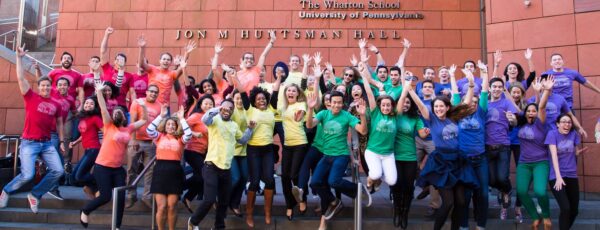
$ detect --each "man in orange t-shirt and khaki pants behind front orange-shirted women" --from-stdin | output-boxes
[125,85,162,208]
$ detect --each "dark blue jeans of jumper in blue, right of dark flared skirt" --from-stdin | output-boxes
[461,154,489,228]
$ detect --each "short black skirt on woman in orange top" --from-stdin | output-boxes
[150,160,185,195]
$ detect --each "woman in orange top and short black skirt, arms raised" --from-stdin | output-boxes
[146,104,192,230]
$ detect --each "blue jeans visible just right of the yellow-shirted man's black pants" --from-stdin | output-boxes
[229,156,248,209]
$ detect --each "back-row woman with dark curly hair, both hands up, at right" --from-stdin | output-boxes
[493,49,535,90]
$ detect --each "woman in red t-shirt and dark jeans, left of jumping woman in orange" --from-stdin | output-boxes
[69,97,104,199]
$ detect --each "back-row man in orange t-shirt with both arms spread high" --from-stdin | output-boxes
[138,34,196,109]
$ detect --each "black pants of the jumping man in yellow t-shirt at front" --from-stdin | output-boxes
[190,163,231,229]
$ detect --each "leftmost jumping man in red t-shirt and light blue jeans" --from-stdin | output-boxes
[0,47,65,213]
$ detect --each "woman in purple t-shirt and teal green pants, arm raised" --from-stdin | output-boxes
[516,78,554,229]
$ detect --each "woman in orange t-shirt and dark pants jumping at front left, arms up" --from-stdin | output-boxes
[79,81,148,228]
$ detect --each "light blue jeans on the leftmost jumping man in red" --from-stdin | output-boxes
[4,139,64,199]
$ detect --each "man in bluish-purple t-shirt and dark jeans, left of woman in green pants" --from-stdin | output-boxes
[485,78,520,217]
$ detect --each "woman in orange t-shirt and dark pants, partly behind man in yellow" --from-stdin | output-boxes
[181,95,215,213]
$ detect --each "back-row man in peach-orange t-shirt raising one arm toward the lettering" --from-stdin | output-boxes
[237,30,277,94]
